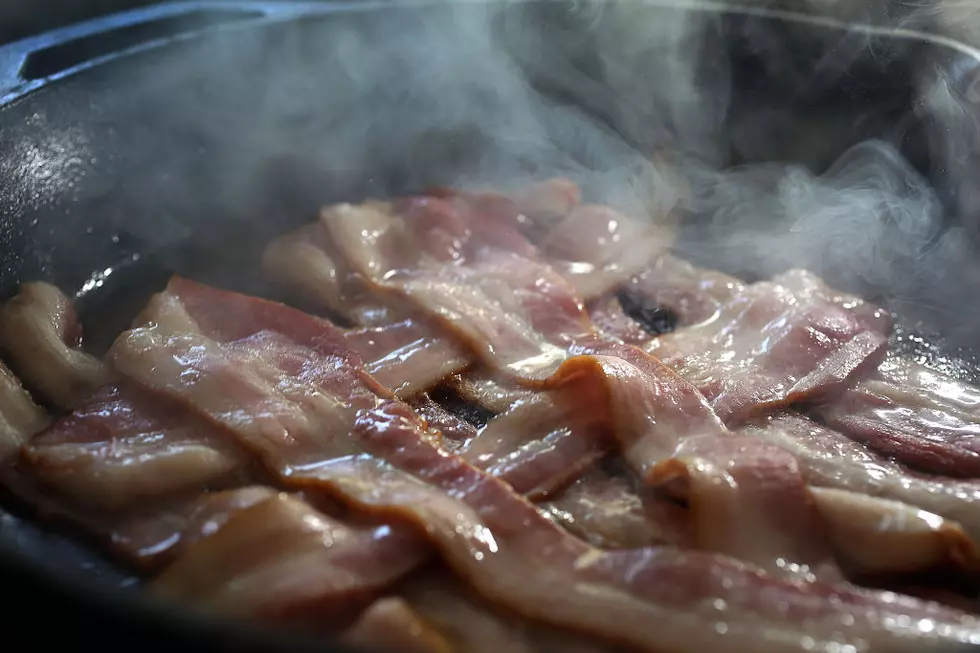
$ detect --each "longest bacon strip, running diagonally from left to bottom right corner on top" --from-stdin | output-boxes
[113,316,976,651]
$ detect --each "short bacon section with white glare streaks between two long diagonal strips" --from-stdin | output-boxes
[344,320,470,399]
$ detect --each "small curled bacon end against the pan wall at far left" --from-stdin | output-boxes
[0,283,108,410]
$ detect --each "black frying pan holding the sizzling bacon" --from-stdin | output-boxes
[0,0,980,651]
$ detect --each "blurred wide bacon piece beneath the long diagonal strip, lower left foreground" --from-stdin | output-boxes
[153,495,428,627]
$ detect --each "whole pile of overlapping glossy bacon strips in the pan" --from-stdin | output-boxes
[0,180,980,653]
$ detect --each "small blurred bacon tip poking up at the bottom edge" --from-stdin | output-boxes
[340,597,453,653]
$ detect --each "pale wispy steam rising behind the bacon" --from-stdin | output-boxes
[82,0,980,346]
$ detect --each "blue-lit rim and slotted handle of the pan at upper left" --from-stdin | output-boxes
[0,0,372,105]
